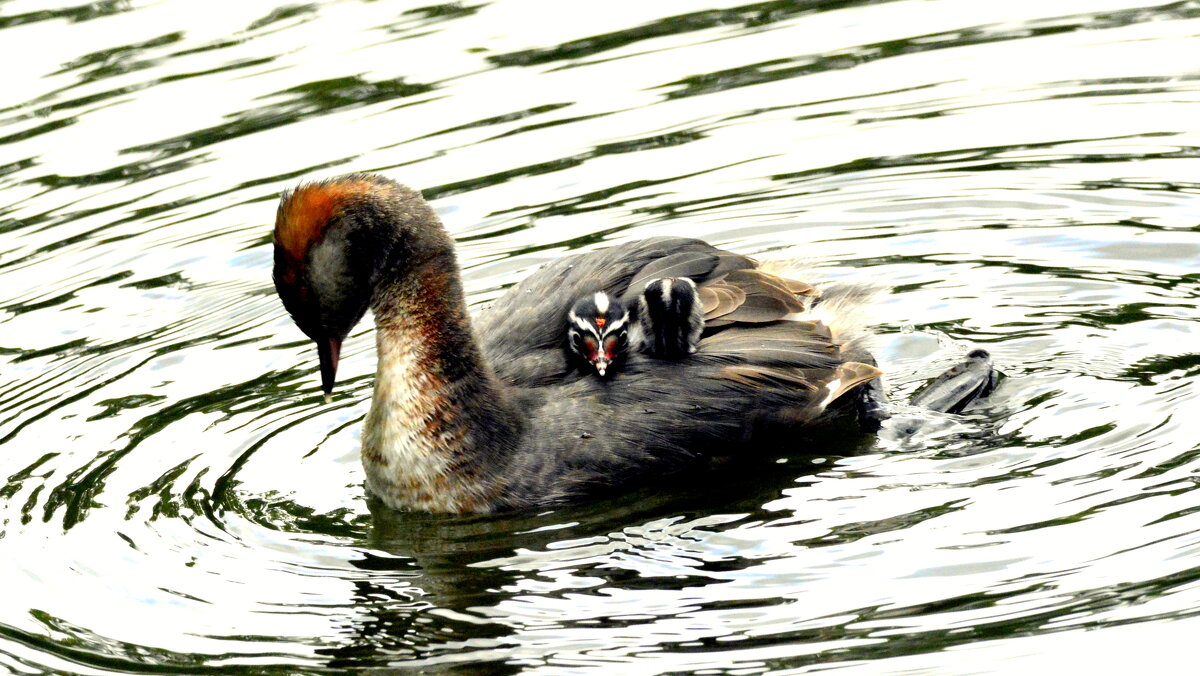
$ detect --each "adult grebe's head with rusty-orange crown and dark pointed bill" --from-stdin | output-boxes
[274,174,404,395]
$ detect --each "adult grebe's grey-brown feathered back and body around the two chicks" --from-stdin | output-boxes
[476,238,880,497]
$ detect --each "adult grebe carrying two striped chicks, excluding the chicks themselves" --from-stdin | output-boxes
[275,174,916,512]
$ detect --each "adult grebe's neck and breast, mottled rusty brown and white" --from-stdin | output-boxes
[362,252,521,512]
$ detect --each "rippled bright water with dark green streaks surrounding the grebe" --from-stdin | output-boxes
[0,0,1200,675]
